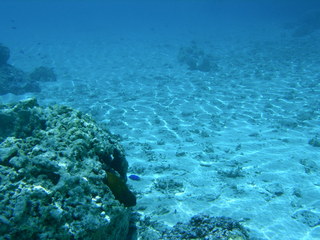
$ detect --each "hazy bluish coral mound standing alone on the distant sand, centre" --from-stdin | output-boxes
[178,42,217,72]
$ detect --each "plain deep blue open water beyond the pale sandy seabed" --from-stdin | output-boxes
[0,0,319,42]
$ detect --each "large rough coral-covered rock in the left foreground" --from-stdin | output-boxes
[0,99,135,239]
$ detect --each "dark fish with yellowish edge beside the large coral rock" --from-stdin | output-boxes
[107,172,137,207]
